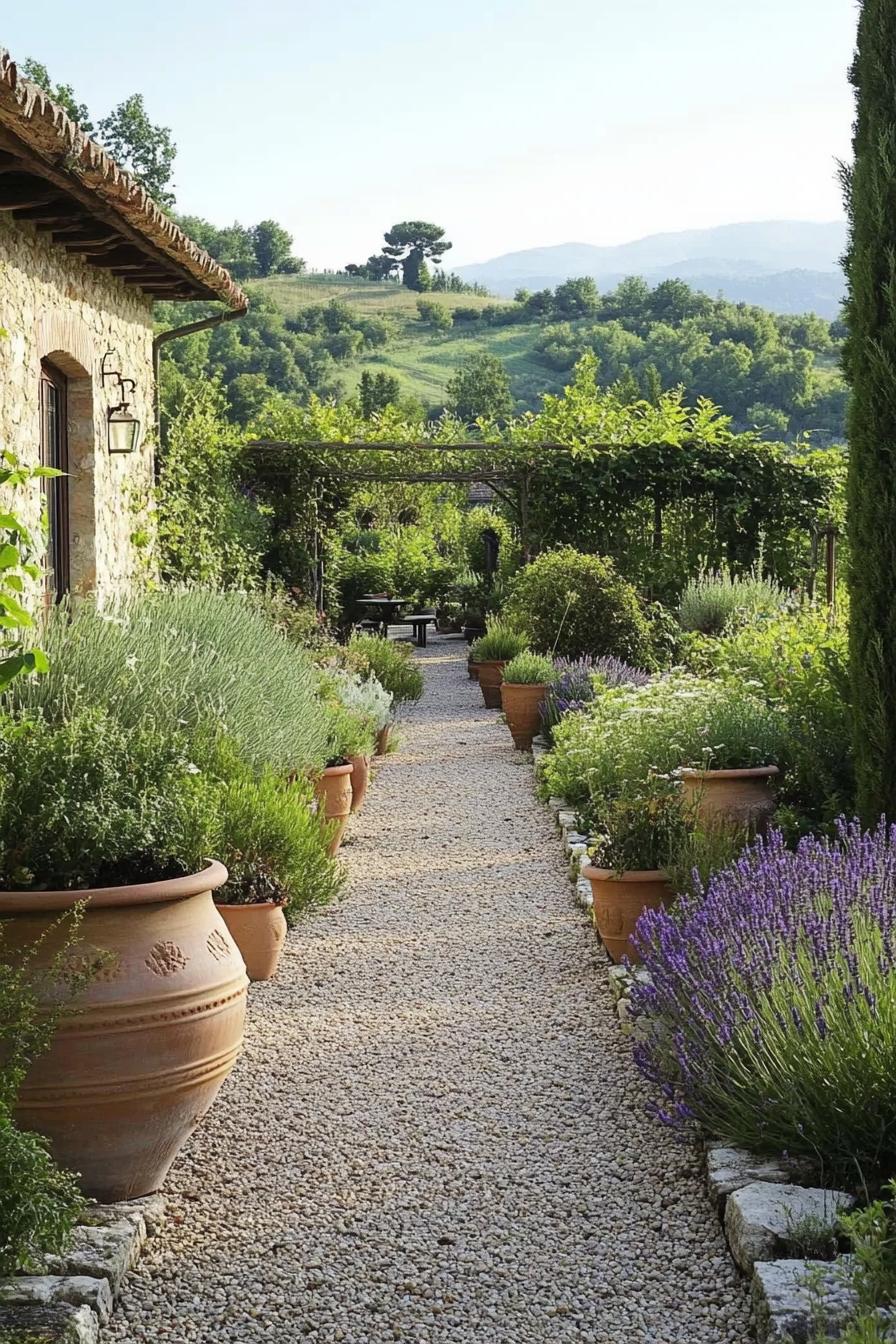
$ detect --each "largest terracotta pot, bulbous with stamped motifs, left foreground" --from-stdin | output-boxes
[0,863,247,1203]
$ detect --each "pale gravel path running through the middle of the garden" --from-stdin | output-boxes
[103,638,750,1344]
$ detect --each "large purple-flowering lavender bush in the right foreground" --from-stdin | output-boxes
[633,821,896,1179]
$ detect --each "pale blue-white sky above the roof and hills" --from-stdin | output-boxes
[0,0,857,269]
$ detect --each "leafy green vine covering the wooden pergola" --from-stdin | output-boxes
[241,356,842,607]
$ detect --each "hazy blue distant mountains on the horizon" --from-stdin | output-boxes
[455,220,846,319]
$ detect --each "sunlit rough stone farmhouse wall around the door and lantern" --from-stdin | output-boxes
[0,211,154,601]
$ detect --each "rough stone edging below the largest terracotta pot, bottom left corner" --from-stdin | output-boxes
[0,1195,165,1344]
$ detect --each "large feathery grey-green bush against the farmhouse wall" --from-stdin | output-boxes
[13,589,333,774]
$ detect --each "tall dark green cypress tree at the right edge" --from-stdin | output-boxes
[844,0,896,823]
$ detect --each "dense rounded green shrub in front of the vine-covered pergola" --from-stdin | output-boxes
[505,546,653,665]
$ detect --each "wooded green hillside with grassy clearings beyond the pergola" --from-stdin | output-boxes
[253,276,846,444]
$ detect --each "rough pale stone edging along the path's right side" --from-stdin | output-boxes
[532,738,859,1344]
